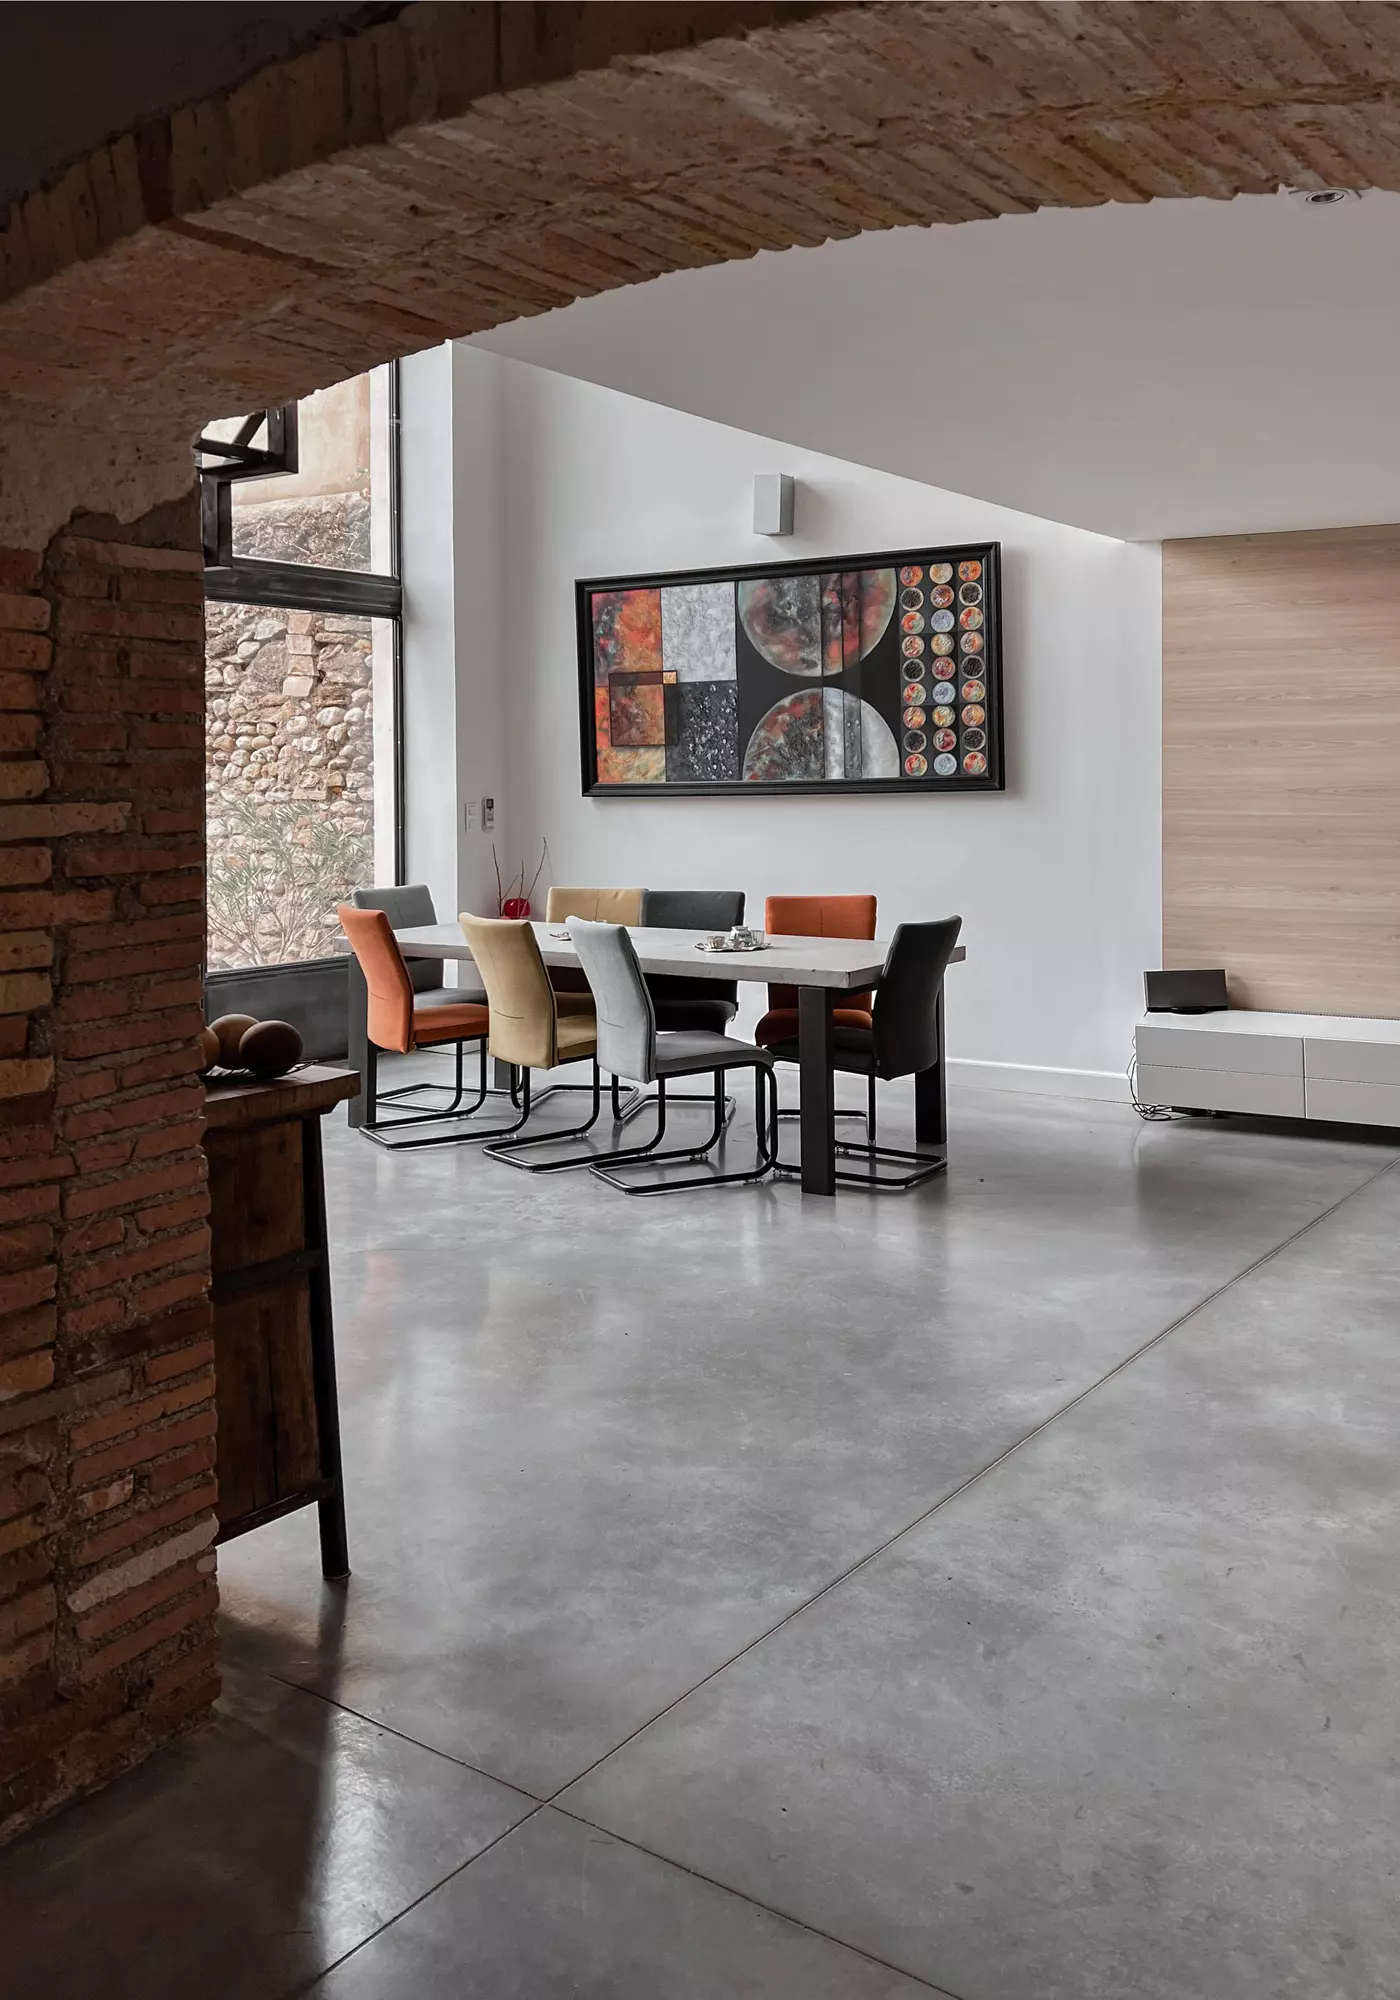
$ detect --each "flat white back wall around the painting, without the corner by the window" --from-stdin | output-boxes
[486,350,1160,1094]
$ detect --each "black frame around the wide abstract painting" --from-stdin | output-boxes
[574,542,1006,798]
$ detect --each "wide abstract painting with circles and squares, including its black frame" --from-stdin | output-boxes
[574,542,1004,798]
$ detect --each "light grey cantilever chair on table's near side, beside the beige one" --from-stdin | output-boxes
[552,918,778,1194]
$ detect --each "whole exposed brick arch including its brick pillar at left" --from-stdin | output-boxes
[0,0,1400,1836]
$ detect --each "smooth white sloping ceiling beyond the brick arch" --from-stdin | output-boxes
[476,192,1400,540]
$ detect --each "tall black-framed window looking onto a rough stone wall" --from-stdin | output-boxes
[200,368,400,972]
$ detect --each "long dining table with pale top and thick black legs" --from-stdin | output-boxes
[348,924,968,1194]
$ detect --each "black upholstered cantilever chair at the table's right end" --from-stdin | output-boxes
[768,916,962,1194]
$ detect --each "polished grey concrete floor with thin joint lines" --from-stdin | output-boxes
[0,1094,1400,2000]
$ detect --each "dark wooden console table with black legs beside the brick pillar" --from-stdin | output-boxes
[204,1064,360,1576]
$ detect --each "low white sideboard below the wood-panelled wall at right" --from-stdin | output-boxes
[1134,1008,1400,1126]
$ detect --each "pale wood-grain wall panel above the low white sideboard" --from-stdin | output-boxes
[1162,526,1400,1016]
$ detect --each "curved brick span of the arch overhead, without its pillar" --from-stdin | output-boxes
[0,0,1400,546]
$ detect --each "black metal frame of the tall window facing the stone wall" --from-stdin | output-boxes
[194,362,404,980]
